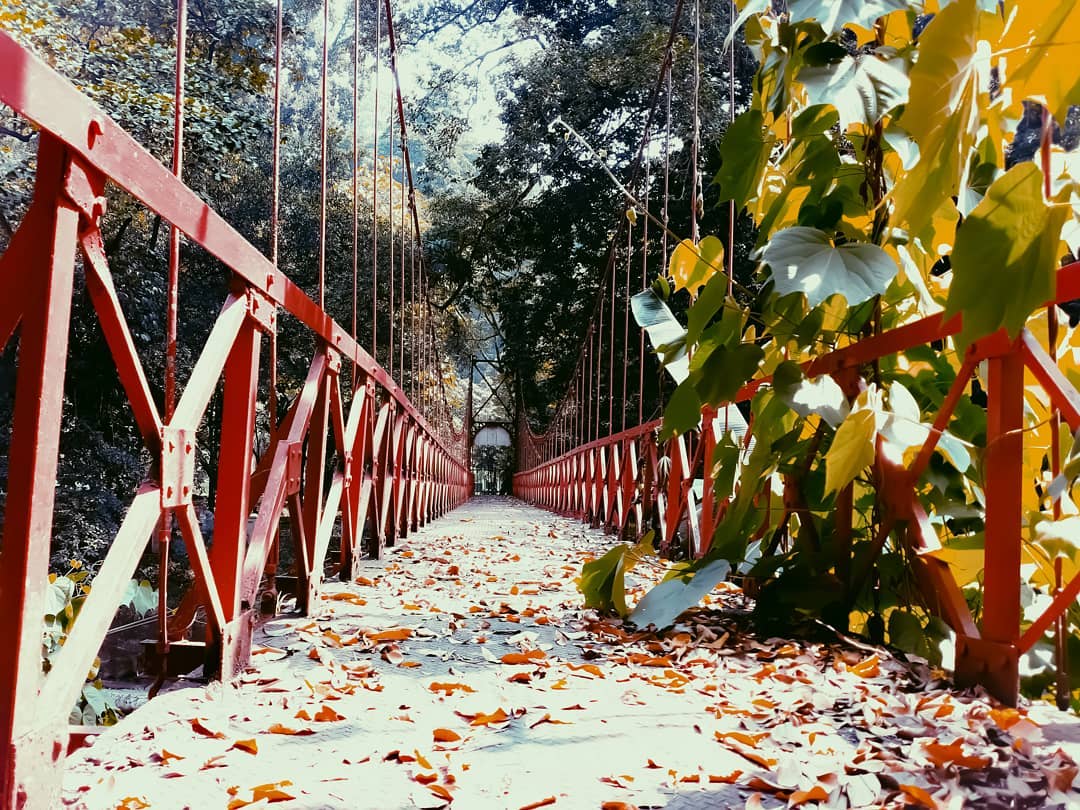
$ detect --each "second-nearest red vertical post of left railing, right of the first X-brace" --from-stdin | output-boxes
[210,318,259,679]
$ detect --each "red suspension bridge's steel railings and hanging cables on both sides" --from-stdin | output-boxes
[6,0,1080,807]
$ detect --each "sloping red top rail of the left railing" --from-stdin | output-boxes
[0,30,461,465]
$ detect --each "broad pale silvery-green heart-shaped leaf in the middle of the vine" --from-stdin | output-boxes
[761,226,900,307]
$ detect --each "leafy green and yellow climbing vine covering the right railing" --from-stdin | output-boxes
[583,0,1080,699]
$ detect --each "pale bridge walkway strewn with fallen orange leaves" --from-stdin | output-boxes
[64,498,1080,810]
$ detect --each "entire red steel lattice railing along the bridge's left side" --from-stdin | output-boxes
[0,31,471,807]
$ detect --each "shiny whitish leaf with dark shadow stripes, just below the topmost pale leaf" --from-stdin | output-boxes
[798,54,910,131]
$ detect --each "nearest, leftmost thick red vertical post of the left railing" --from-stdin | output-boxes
[0,133,79,808]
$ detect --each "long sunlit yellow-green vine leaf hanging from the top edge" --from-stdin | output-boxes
[891,0,982,237]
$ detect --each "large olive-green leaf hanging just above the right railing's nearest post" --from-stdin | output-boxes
[945,163,1069,350]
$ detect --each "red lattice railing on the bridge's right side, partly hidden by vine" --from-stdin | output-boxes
[514,262,1080,703]
